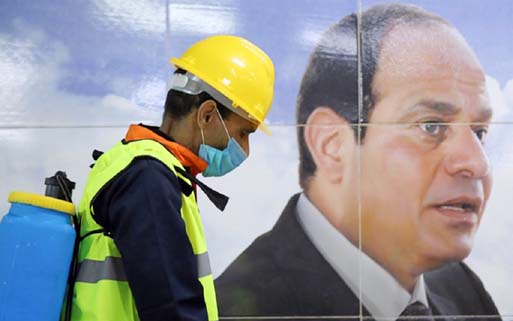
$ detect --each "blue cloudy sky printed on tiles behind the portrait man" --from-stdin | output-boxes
[0,0,513,316]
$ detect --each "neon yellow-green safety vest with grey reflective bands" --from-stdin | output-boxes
[72,139,218,321]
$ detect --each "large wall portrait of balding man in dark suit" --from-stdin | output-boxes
[216,4,500,319]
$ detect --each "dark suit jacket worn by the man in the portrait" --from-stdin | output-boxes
[216,194,500,320]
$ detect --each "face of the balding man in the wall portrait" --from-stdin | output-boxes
[360,25,491,272]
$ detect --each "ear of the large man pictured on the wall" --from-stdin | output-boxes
[304,107,354,184]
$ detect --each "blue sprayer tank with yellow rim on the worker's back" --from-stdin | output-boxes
[0,171,78,321]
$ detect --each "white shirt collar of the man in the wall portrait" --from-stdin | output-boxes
[297,193,429,321]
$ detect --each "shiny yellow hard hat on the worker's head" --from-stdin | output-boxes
[170,35,274,132]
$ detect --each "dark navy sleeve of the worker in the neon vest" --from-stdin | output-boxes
[93,158,208,321]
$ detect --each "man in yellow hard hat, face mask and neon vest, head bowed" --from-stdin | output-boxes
[72,36,274,321]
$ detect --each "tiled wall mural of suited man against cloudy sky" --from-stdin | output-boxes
[0,0,513,320]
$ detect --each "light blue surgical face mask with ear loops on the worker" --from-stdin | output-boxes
[199,108,247,177]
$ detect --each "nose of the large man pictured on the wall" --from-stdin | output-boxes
[445,125,490,179]
